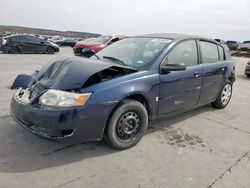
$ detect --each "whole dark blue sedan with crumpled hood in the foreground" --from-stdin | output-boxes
[11,34,235,149]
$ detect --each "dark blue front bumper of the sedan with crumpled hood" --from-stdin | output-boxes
[10,89,115,142]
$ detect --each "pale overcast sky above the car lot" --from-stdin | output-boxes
[0,0,250,40]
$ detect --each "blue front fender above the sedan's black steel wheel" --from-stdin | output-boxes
[82,74,159,117]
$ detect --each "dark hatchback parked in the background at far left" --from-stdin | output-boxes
[0,35,59,54]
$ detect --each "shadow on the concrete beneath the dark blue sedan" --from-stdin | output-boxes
[0,105,213,173]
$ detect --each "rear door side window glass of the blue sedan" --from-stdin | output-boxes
[200,41,219,63]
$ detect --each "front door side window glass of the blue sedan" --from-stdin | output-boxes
[164,40,198,66]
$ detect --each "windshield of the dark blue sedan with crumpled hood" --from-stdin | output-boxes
[91,38,171,70]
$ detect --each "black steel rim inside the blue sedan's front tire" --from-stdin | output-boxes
[116,111,141,140]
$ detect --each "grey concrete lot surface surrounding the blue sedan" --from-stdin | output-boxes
[0,48,250,188]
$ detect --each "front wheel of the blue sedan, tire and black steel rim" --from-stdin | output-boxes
[104,100,148,149]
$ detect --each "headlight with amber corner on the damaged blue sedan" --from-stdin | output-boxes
[39,89,91,107]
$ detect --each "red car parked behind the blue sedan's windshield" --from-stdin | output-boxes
[73,35,125,57]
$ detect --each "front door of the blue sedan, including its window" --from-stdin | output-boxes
[158,40,202,115]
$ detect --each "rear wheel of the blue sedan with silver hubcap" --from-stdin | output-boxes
[212,81,233,109]
